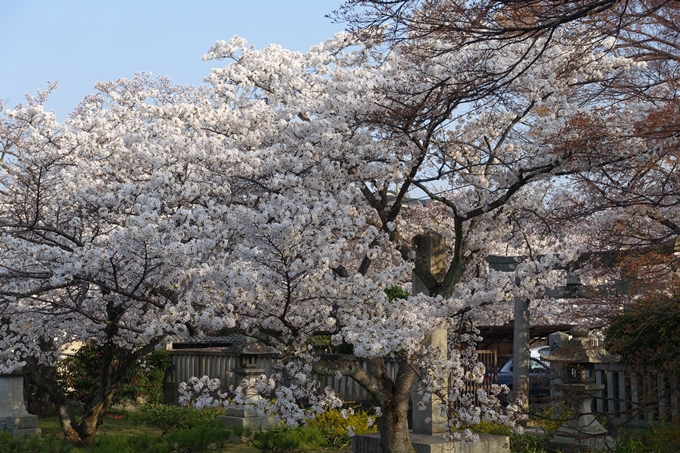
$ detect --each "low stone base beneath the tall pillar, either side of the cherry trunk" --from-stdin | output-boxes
[352,433,510,453]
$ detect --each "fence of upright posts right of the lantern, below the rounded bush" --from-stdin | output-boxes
[593,364,680,426]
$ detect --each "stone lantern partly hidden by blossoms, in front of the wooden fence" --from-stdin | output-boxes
[219,339,279,430]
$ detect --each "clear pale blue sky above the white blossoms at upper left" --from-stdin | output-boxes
[0,0,343,120]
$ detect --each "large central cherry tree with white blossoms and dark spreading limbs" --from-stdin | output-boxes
[185,30,630,451]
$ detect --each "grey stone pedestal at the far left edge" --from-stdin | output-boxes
[0,369,40,438]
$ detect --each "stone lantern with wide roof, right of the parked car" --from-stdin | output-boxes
[543,326,615,451]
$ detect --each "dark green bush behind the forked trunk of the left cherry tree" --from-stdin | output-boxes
[59,344,172,404]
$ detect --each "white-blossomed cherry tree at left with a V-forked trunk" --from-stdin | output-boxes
[0,76,233,444]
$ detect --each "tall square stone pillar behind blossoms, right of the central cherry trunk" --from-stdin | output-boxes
[411,231,448,435]
